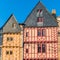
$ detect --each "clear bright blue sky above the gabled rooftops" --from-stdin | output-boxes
[0,0,60,27]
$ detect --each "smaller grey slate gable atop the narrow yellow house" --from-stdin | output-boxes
[3,14,21,33]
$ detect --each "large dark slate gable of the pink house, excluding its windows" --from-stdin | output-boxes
[24,2,58,27]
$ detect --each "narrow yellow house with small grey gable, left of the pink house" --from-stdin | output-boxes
[2,15,23,60]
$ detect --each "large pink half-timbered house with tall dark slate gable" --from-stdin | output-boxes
[23,2,58,60]
